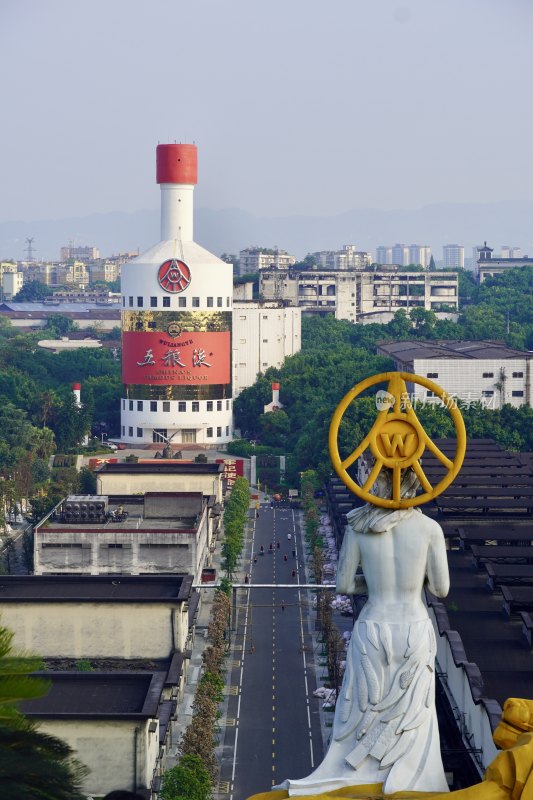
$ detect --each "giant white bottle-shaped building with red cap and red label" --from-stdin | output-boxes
[121,144,233,447]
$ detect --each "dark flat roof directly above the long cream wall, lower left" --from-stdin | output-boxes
[0,574,193,604]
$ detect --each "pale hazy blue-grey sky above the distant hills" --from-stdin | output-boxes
[0,0,533,221]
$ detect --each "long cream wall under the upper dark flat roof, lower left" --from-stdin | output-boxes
[0,600,188,659]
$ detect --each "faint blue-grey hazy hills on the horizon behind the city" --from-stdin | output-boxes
[0,202,533,260]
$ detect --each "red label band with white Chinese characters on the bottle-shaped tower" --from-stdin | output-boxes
[122,331,231,386]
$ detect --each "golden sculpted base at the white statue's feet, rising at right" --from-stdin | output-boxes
[248,698,533,800]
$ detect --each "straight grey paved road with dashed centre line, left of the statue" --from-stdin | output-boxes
[220,505,322,800]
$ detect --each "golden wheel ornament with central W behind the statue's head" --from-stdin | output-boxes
[329,372,466,508]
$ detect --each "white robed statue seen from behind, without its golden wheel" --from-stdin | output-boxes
[276,469,449,796]
